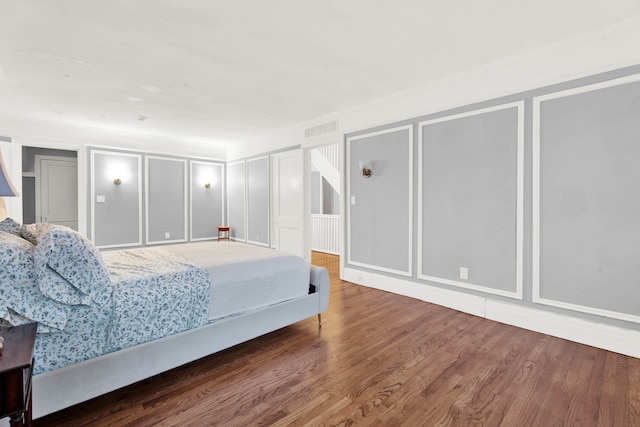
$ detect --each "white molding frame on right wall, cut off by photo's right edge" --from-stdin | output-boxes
[531,74,640,323]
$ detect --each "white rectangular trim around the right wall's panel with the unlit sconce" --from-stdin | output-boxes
[345,124,413,277]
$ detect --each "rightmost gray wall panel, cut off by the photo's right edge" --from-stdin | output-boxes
[534,76,640,322]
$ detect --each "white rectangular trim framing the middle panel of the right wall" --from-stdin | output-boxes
[417,101,524,300]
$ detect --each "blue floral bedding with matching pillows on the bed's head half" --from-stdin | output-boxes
[0,220,211,374]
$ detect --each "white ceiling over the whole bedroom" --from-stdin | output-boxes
[0,0,640,149]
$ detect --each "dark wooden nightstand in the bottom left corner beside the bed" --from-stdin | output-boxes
[0,323,38,427]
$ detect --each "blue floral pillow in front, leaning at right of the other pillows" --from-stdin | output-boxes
[31,224,113,306]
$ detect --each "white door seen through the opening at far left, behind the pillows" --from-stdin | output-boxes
[35,156,78,230]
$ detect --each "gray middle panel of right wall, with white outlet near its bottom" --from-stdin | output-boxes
[418,103,524,298]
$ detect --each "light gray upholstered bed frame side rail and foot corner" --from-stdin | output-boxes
[33,265,329,418]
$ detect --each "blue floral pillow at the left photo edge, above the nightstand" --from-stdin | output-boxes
[0,231,68,330]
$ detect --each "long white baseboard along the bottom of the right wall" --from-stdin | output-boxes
[343,268,640,358]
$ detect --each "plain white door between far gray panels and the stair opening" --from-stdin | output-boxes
[271,150,308,259]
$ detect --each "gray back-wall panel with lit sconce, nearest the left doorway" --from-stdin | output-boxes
[90,150,142,248]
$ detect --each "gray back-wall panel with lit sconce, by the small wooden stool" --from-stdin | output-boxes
[189,160,226,240]
